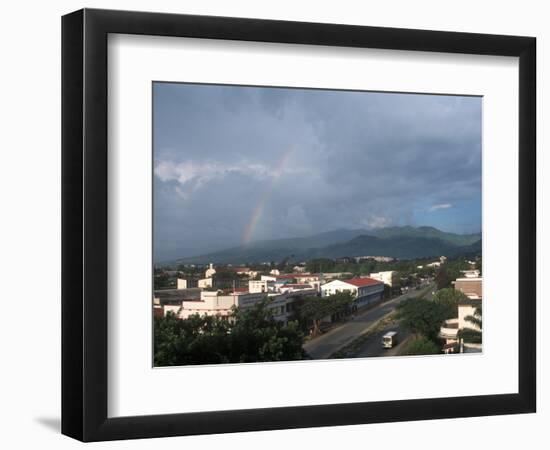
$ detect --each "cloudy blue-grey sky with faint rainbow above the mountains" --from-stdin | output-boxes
[153,83,482,261]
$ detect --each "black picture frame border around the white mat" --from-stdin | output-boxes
[62,9,536,441]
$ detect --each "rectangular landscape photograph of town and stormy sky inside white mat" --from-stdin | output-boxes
[152,81,483,367]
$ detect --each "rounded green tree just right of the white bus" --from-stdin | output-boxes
[396,297,454,342]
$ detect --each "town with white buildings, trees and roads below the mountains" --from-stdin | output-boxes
[153,255,482,366]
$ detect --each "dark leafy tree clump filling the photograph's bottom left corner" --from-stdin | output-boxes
[154,301,305,366]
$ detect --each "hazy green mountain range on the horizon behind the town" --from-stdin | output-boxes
[175,226,481,264]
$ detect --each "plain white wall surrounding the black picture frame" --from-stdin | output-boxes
[0,0,550,450]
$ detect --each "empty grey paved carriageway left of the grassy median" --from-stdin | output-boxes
[304,286,432,359]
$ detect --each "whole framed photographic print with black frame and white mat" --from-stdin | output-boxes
[62,9,536,441]
